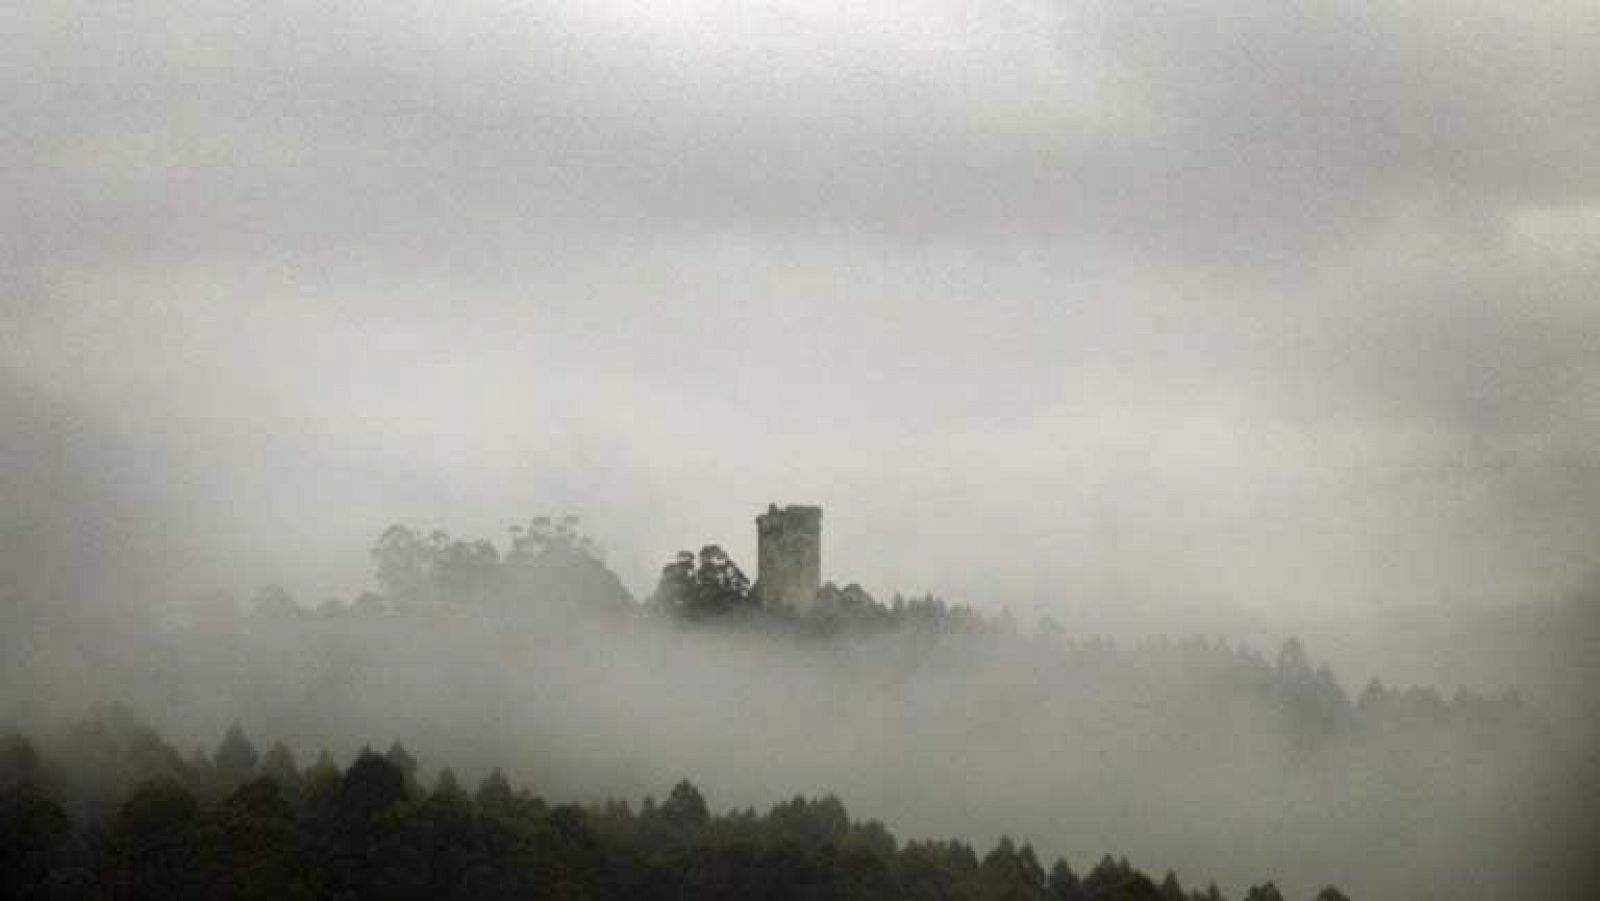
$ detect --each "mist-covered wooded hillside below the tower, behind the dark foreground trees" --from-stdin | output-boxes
[0,519,1600,899]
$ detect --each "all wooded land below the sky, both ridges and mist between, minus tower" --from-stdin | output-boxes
[0,519,1600,901]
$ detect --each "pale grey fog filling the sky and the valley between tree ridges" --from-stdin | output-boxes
[0,0,1600,898]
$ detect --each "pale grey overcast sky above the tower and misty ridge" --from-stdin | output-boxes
[0,0,1600,611]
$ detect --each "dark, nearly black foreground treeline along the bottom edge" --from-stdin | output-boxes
[0,709,1344,901]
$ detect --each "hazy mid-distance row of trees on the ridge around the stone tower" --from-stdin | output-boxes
[222,517,1534,743]
